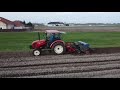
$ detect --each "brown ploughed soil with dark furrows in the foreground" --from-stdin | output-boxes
[0,48,120,78]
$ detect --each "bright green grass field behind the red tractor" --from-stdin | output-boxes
[0,32,120,51]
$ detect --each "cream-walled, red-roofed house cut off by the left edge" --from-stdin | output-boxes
[0,17,14,29]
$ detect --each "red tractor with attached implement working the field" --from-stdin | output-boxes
[30,30,91,56]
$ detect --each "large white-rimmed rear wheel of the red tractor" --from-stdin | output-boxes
[52,42,65,55]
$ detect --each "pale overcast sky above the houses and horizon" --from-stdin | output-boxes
[0,12,120,23]
